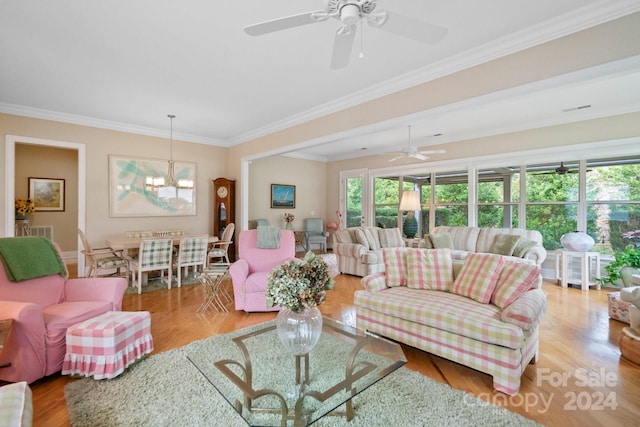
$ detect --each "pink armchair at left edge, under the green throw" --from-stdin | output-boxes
[0,239,127,383]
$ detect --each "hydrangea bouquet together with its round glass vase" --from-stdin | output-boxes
[266,251,334,356]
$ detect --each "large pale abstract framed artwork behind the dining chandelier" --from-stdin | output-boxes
[109,155,197,217]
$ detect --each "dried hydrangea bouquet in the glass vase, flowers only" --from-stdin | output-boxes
[267,251,334,313]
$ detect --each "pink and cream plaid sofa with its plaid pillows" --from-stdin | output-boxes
[354,248,546,395]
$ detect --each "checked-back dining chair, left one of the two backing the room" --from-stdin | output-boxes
[125,239,173,294]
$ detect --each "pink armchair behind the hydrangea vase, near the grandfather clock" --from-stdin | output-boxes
[229,230,296,312]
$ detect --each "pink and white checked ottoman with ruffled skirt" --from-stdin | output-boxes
[62,311,153,380]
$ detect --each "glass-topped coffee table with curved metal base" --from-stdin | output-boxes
[187,317,407,426]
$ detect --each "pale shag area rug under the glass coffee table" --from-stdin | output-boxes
[65,322,538,427]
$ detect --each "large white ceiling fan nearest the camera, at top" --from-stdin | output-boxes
[244,0,448,69]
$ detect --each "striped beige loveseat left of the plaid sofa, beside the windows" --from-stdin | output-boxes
[333,227,404,277]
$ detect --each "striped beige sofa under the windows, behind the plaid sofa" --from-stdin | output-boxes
[420,226,547,265]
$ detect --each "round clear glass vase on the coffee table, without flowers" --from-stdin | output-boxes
[276,307,322,356]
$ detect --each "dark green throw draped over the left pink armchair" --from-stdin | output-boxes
[0,237,67,282]
